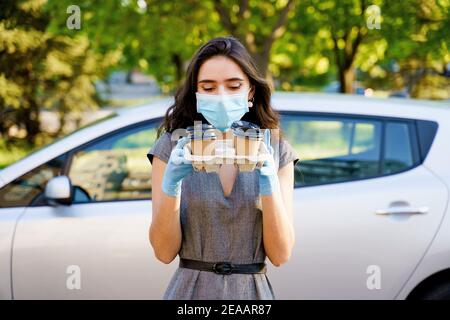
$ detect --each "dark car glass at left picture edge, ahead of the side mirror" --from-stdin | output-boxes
[0,154,66,208]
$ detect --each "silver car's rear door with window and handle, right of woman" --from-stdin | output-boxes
[270,112,447,299]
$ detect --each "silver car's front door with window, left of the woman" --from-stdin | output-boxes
[13,120,175,299]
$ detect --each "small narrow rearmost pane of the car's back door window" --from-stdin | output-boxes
[383,122,414,174]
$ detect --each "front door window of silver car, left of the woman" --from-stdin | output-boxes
[69,122,159,202]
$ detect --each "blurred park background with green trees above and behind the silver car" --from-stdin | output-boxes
[0,0,450,169]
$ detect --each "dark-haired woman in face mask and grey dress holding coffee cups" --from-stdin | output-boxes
[148,37,298,299]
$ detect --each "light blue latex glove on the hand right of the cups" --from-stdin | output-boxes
[259,129,278,196]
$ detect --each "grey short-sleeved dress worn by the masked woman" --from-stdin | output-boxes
[147,132,298,300]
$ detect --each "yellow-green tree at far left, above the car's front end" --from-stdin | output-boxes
[0,0,114,144]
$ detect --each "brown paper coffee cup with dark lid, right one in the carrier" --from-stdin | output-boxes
[232,121,264,157]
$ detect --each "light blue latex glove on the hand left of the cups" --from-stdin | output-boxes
[162,137,194,197]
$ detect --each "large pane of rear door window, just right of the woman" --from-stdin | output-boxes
[281,114,382,186]
